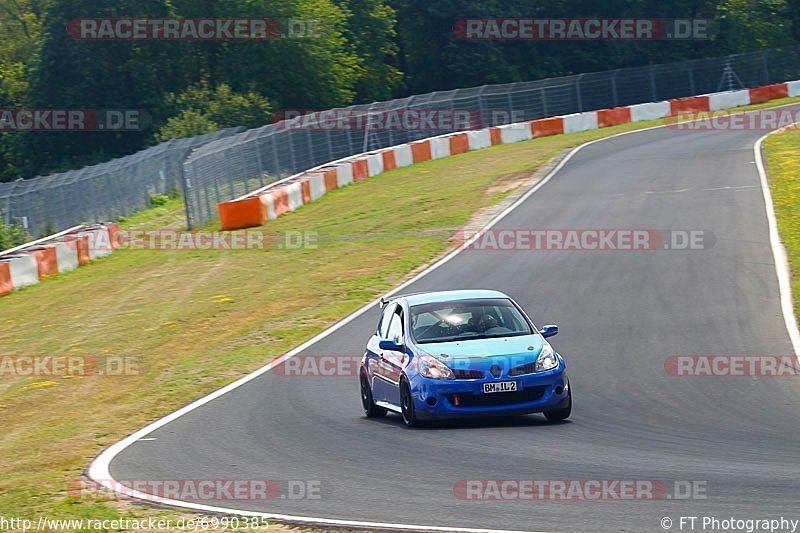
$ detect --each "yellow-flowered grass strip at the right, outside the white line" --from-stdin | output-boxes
[764,124,800,316]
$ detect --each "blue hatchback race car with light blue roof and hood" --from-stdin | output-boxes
[359,290,572,426]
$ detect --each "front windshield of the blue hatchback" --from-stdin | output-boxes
[411,298,533,343]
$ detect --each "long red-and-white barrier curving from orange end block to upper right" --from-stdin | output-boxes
[214,81,800,229]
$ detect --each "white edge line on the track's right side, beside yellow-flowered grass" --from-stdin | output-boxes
[753,130,800,361]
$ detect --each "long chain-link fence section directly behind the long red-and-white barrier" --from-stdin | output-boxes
[184,47,800,227]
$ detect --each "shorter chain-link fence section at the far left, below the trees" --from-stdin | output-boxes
[0,127,245,237]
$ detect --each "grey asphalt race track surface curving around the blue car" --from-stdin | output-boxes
[111,109,800,531]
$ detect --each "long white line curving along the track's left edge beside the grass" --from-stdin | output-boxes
[88,102,798,533]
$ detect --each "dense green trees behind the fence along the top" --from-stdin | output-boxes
[0,0,800,181]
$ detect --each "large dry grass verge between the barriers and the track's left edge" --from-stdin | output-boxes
[0,99,799,528]
